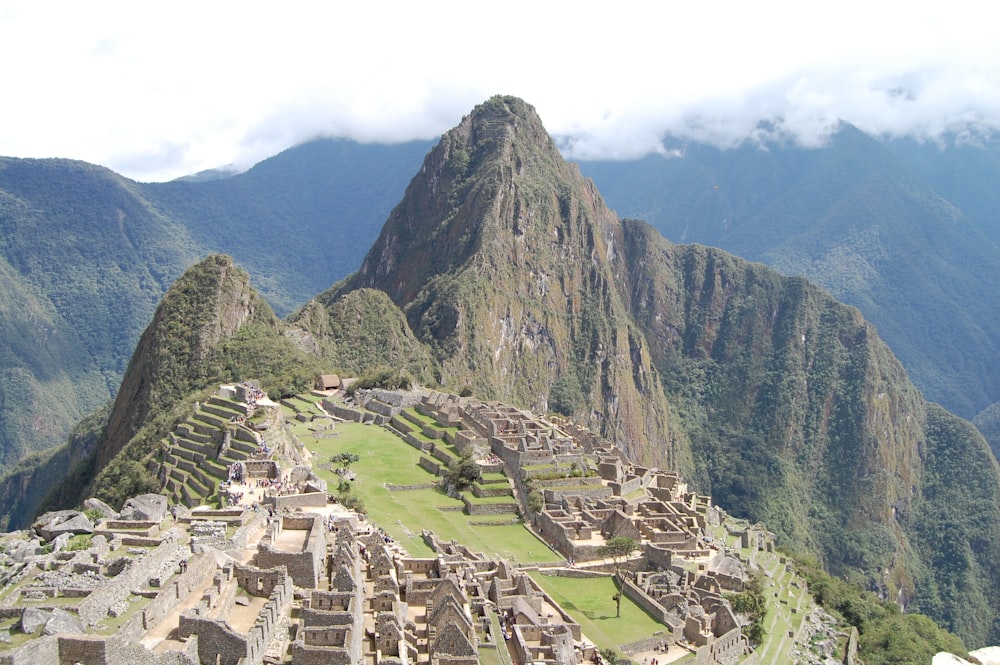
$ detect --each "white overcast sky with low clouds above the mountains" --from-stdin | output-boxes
[0,0,1000,181]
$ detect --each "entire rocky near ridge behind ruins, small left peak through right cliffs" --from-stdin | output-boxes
[15,97,1000,645]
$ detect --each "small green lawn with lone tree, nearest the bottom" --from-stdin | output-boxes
[531,573,666,649]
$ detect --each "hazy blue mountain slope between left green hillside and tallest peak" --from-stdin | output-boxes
[143,139,432,316]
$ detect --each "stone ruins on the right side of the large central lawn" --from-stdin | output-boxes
[376,391,773,663]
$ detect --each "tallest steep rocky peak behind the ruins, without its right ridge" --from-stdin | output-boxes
[328,97,688,466]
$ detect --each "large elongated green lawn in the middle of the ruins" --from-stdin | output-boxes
[292,423,562,563]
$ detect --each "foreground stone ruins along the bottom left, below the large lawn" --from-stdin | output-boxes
[0,498,594,665]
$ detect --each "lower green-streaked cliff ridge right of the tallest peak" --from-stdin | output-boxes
[624,221,1000,644]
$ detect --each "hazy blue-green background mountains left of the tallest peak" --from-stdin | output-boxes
[0,140,430,472]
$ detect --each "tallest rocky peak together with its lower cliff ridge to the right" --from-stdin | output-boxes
[321,97,1000,644]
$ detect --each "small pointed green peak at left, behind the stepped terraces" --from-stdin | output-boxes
[34,255,320,507]
